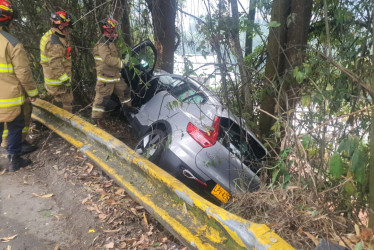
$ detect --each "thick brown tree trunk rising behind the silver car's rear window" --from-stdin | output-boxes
[260,0,313,141]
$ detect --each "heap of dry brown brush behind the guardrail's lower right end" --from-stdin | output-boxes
[227,187,374,249]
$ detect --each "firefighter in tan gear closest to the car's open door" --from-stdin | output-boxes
[91,18,130,126]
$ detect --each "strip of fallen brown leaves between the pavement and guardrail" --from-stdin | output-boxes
[51,146,181,249]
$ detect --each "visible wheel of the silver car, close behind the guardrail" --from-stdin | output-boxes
[135,129,167,163]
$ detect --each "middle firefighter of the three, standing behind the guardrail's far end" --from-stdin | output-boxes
[40,11,73,112]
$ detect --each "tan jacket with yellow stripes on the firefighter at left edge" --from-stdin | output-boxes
[0,27,38,122]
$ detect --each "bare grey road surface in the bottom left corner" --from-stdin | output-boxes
[0,151,95,250]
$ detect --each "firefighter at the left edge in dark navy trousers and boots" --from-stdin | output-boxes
[0,0,38,172]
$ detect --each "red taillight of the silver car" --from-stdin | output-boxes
[187,116,220,148]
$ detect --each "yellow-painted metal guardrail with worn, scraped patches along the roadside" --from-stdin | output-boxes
[32,99,293,250]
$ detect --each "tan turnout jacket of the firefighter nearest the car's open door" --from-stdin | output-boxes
[93,37,123,83]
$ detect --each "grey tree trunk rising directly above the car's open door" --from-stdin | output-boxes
[146,0,177,73]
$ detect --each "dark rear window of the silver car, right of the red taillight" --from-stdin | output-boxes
[218,117,266,168]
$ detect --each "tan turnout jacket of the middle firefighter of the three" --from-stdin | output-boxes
[40,28,72,86]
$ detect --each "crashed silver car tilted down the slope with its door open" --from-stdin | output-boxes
[122,41,267,202]
